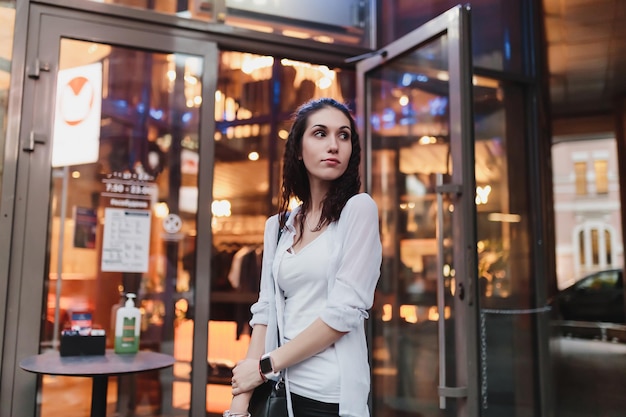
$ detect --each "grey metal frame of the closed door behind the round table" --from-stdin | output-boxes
[0,5,218,417]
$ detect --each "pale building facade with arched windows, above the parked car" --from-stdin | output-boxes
[552,138,624,288]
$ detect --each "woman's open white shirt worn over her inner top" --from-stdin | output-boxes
[250,193,382,417]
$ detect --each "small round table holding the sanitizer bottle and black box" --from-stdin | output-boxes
[20,350,174,417]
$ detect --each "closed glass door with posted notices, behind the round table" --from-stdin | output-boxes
[6,6,217,417]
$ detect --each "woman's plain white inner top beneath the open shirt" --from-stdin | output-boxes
[278,231,339,403]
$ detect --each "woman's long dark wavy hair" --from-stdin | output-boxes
[279,98,361,236]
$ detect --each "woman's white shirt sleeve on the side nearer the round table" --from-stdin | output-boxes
[250,215,278,327]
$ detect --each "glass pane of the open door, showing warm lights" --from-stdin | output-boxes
[368,36,456,416]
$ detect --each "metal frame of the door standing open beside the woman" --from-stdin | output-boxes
[357,6,481,417]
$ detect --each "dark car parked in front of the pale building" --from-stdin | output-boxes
[554,269,626,323]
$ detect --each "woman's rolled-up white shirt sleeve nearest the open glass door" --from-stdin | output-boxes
[321,193,382,332]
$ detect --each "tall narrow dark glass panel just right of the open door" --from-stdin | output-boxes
[474,77,542,416]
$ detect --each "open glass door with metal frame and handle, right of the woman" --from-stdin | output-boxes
[357,6,479,417]
